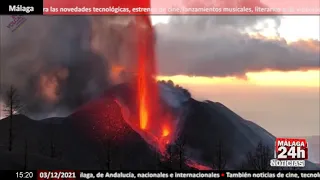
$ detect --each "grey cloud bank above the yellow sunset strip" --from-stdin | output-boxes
[156,16,320,77]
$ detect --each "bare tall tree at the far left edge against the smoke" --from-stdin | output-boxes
[4,86,23,151]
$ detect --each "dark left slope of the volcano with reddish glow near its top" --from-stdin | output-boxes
[0,89,166,170]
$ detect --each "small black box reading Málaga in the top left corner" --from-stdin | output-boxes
[0,0,43,15]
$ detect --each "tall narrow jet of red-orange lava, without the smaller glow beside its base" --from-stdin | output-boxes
[136,16,159,130]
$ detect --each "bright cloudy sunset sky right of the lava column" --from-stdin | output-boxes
[152,16,320,136]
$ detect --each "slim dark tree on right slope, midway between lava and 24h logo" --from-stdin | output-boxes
[212,139,227,170]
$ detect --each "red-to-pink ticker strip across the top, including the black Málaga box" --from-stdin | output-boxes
[1,0,320,15]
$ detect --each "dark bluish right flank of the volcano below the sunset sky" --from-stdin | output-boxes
[180,99,320,170]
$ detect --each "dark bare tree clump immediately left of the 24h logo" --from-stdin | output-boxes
[242,141,273,170]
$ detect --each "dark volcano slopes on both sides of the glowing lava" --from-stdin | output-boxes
[0,83,319,170]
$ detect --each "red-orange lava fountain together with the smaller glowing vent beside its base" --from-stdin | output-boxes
[136,8,172,152]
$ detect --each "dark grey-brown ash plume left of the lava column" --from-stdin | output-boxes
[1,16,138,118]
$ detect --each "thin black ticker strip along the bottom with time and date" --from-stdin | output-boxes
[0,170,320,180]
